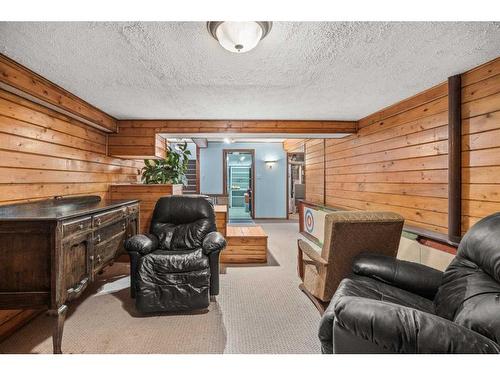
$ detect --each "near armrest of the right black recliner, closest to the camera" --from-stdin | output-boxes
[334,297,500,354]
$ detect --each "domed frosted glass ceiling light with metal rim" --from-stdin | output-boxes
[207,21,273,53]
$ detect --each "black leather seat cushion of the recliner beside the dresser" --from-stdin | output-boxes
[138,249,209,279]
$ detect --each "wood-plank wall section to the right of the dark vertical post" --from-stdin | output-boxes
[462,58,500,232]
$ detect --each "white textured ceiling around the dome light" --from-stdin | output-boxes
[0,22,500,120]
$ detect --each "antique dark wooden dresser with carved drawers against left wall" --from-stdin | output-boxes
[0,196,139,353]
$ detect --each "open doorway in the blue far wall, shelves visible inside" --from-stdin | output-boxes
[223,149,255,223]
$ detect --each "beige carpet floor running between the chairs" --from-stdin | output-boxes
[0,221,320,354]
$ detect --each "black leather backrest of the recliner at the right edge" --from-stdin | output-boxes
[434,213,500,343]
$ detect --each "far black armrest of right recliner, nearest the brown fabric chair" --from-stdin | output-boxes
[352,253,443,299]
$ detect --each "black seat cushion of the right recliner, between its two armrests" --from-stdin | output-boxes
[330,275,434,314]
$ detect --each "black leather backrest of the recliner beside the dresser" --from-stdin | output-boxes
[150,195,217,250]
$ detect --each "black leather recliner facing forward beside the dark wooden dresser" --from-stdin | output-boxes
[125,196,226,313]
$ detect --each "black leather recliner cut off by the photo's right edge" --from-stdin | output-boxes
[319,213,500,353]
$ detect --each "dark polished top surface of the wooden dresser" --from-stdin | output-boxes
[0,196,139,221]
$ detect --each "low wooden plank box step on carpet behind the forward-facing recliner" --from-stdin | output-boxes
[220,225,267,263]
